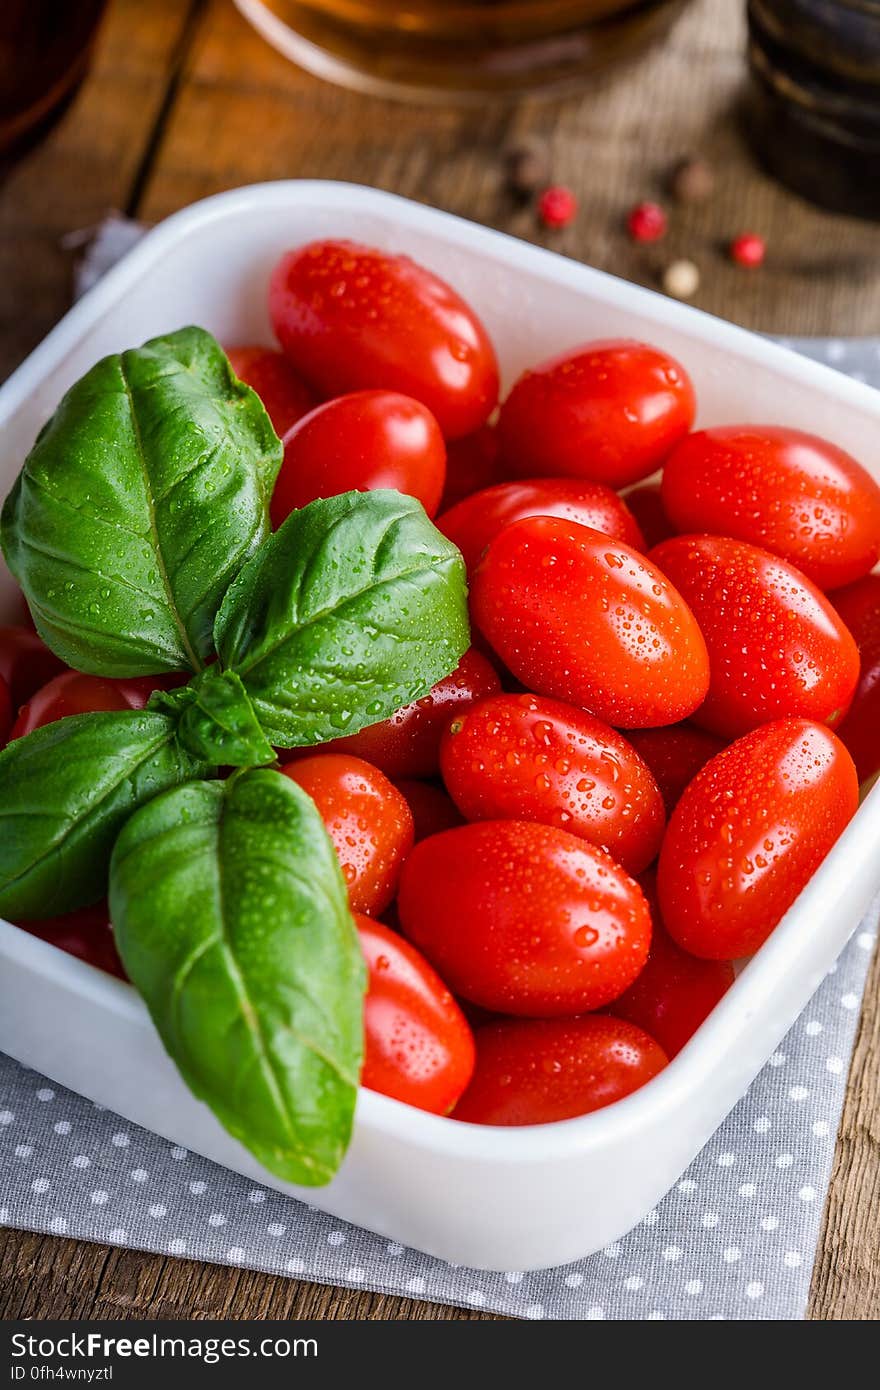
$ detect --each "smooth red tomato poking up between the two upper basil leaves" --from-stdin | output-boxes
[271,391,446,527]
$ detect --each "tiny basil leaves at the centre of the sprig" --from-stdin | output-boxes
[149,666,275,767]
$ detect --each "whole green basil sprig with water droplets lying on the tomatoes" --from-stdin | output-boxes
[0,328,468,1184]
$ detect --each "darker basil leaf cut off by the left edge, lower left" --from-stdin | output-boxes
[0,709,209,922]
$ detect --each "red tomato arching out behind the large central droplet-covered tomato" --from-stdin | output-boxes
[437,478,645,570]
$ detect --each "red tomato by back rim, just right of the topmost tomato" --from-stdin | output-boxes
[498,338,696,488]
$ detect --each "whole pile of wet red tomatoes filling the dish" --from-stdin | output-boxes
[0,242,880,1125]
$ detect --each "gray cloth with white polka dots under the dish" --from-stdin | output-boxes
[0,293,880,1319]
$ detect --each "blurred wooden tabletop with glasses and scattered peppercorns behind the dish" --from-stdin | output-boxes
[0,0,880,378]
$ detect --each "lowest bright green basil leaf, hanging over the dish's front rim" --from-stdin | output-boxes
[110,770,366,1186]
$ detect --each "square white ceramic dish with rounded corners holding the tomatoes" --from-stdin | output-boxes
[0,182,880,1269]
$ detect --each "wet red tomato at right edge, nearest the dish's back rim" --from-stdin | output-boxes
[663,425,880,589]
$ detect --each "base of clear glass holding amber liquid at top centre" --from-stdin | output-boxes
[235,0,687,100]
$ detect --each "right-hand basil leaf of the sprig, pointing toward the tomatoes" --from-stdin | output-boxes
[214,492,468,748]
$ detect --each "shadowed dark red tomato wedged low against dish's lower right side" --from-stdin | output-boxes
[613,873,734,1058]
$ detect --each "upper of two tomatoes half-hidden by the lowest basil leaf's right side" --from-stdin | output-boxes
[281,753,413,913]
